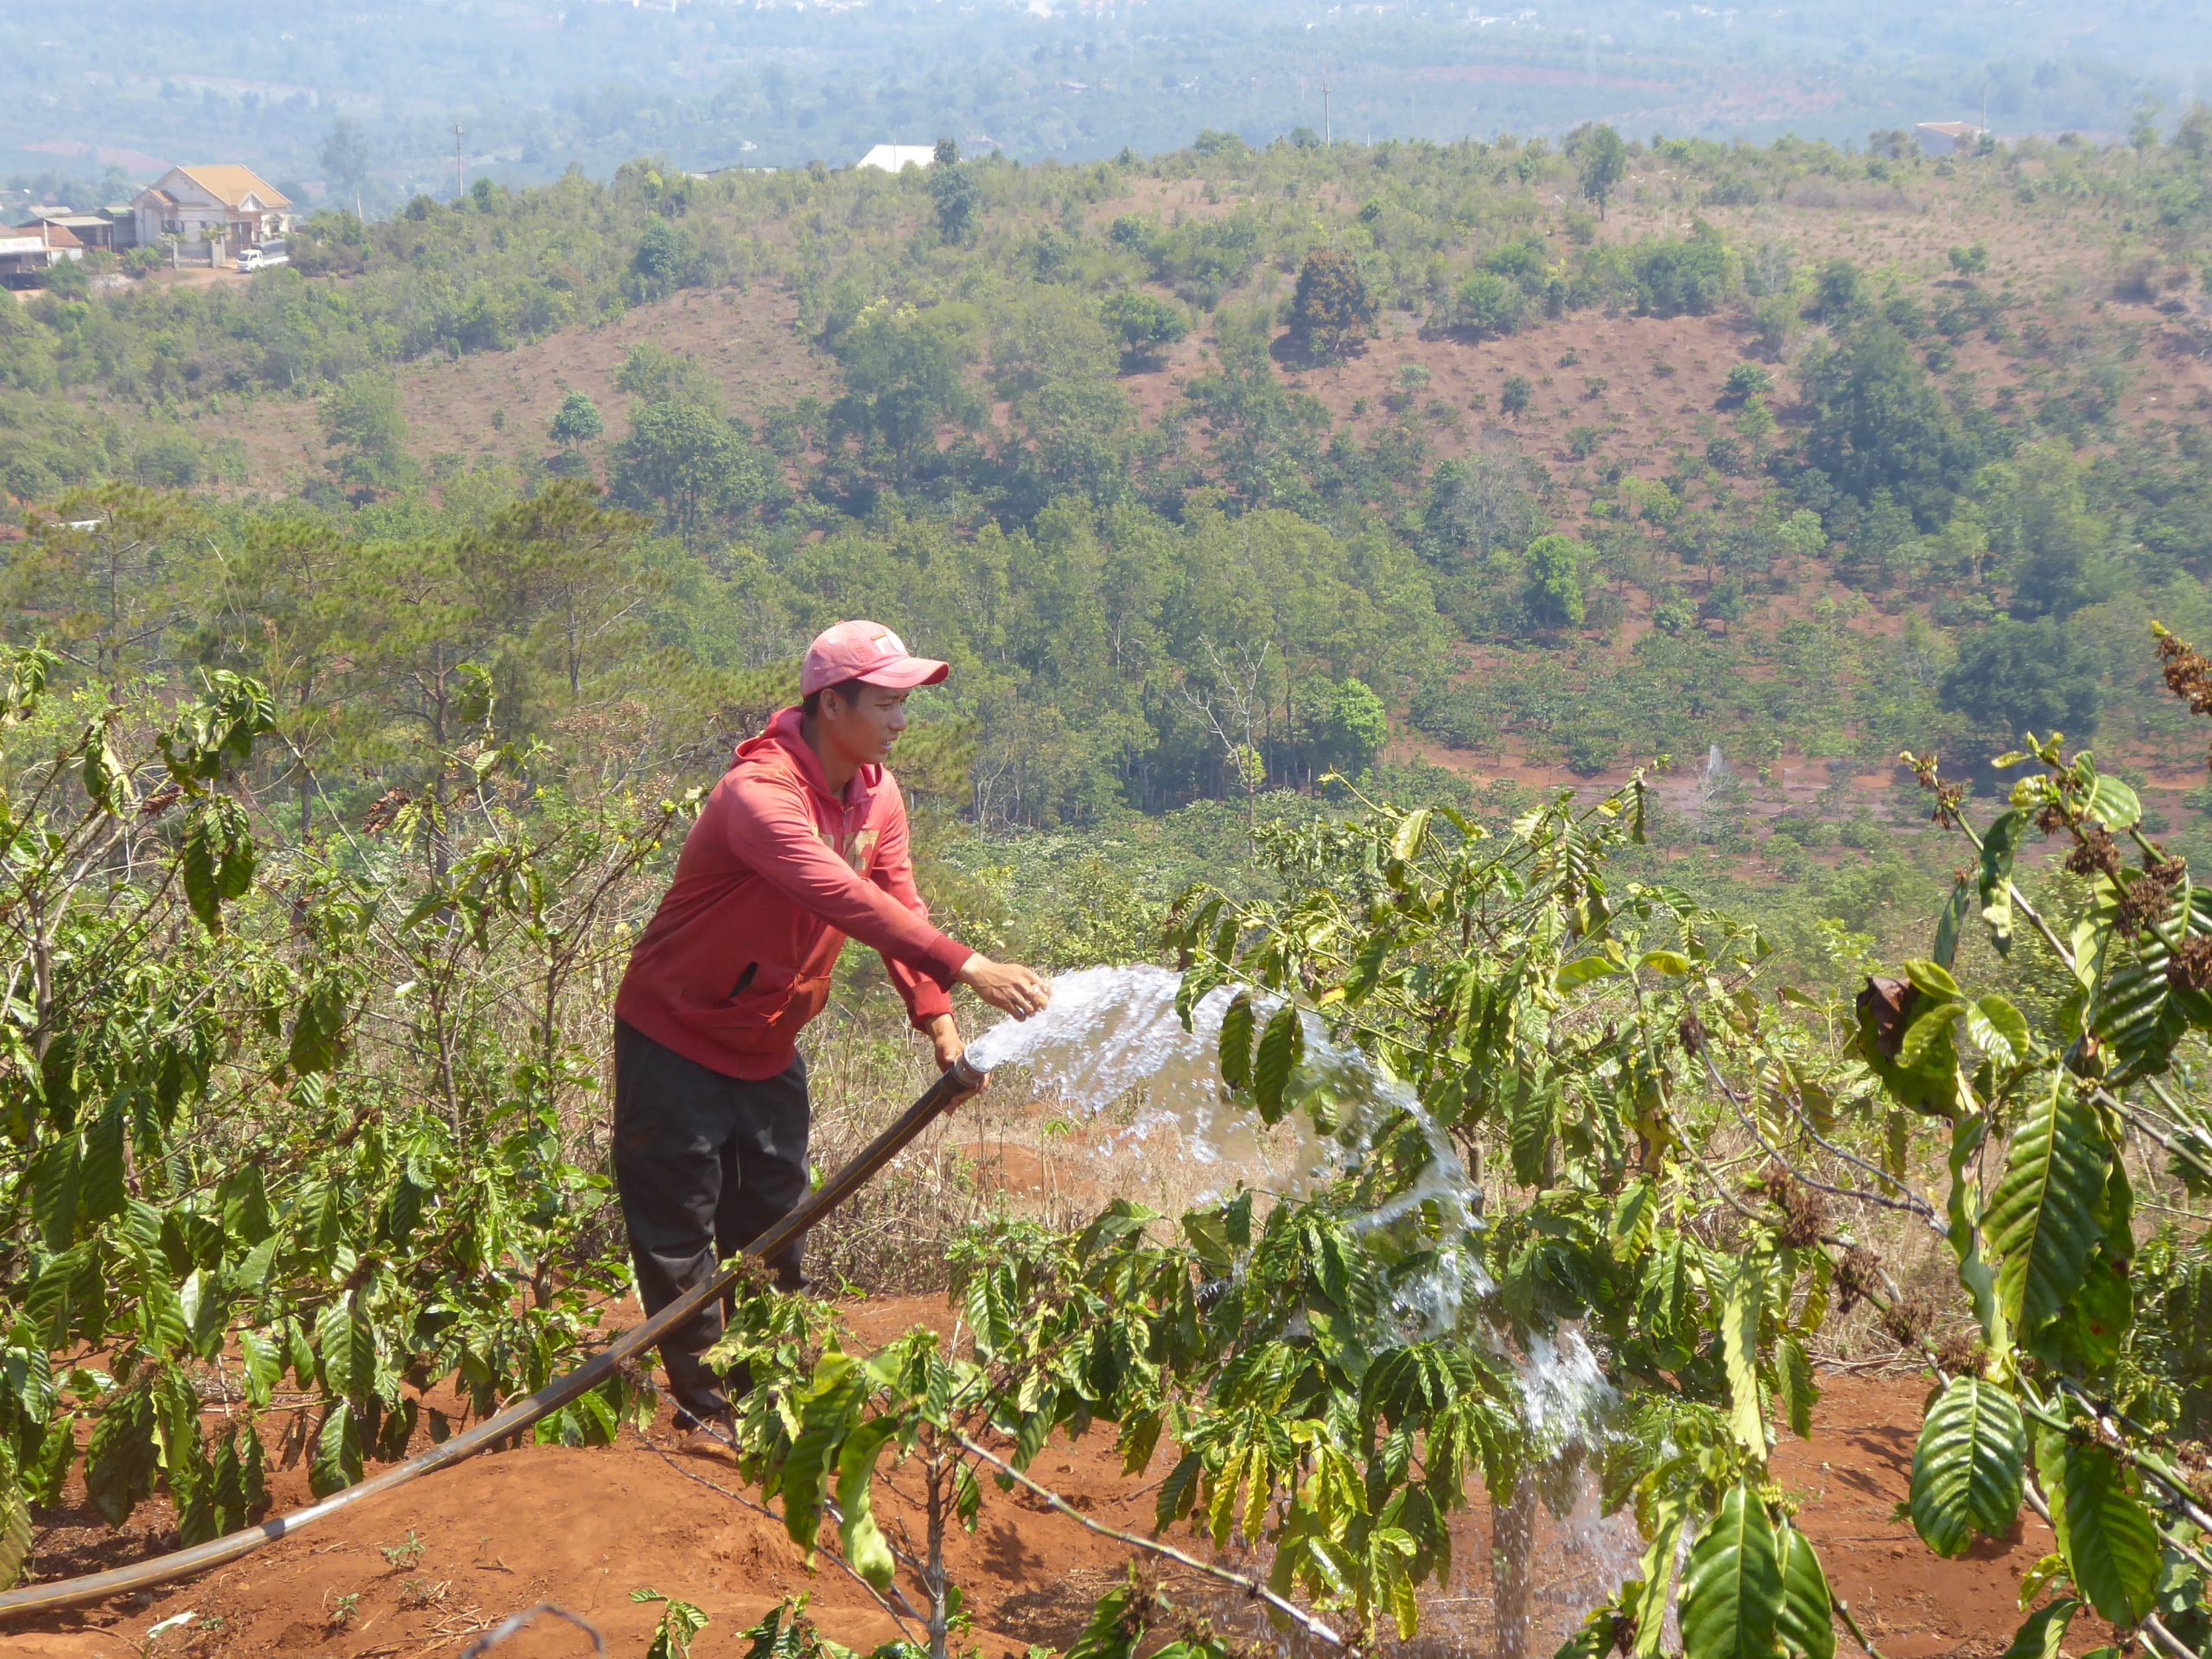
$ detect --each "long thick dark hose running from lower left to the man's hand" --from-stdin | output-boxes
[0,1059,984,1619]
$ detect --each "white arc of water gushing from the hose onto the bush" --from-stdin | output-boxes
[969,967,1642,1652]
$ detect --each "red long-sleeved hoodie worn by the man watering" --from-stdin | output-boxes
[615,708,969,1082]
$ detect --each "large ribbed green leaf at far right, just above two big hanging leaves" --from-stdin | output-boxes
[1986,1073,2113,1336]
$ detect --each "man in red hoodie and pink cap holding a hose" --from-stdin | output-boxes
[615,621,1051,1451]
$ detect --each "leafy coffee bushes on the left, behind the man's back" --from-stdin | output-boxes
[0,651,675,1584]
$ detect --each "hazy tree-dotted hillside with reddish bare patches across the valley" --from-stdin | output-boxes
[0,130,2212,973]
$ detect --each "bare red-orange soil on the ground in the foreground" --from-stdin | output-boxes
[0,1299,2050,1659]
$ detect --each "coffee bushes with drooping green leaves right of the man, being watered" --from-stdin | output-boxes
[732,623,2212,1659]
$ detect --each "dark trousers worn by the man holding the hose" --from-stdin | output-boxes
[615,1020,807,1422]
